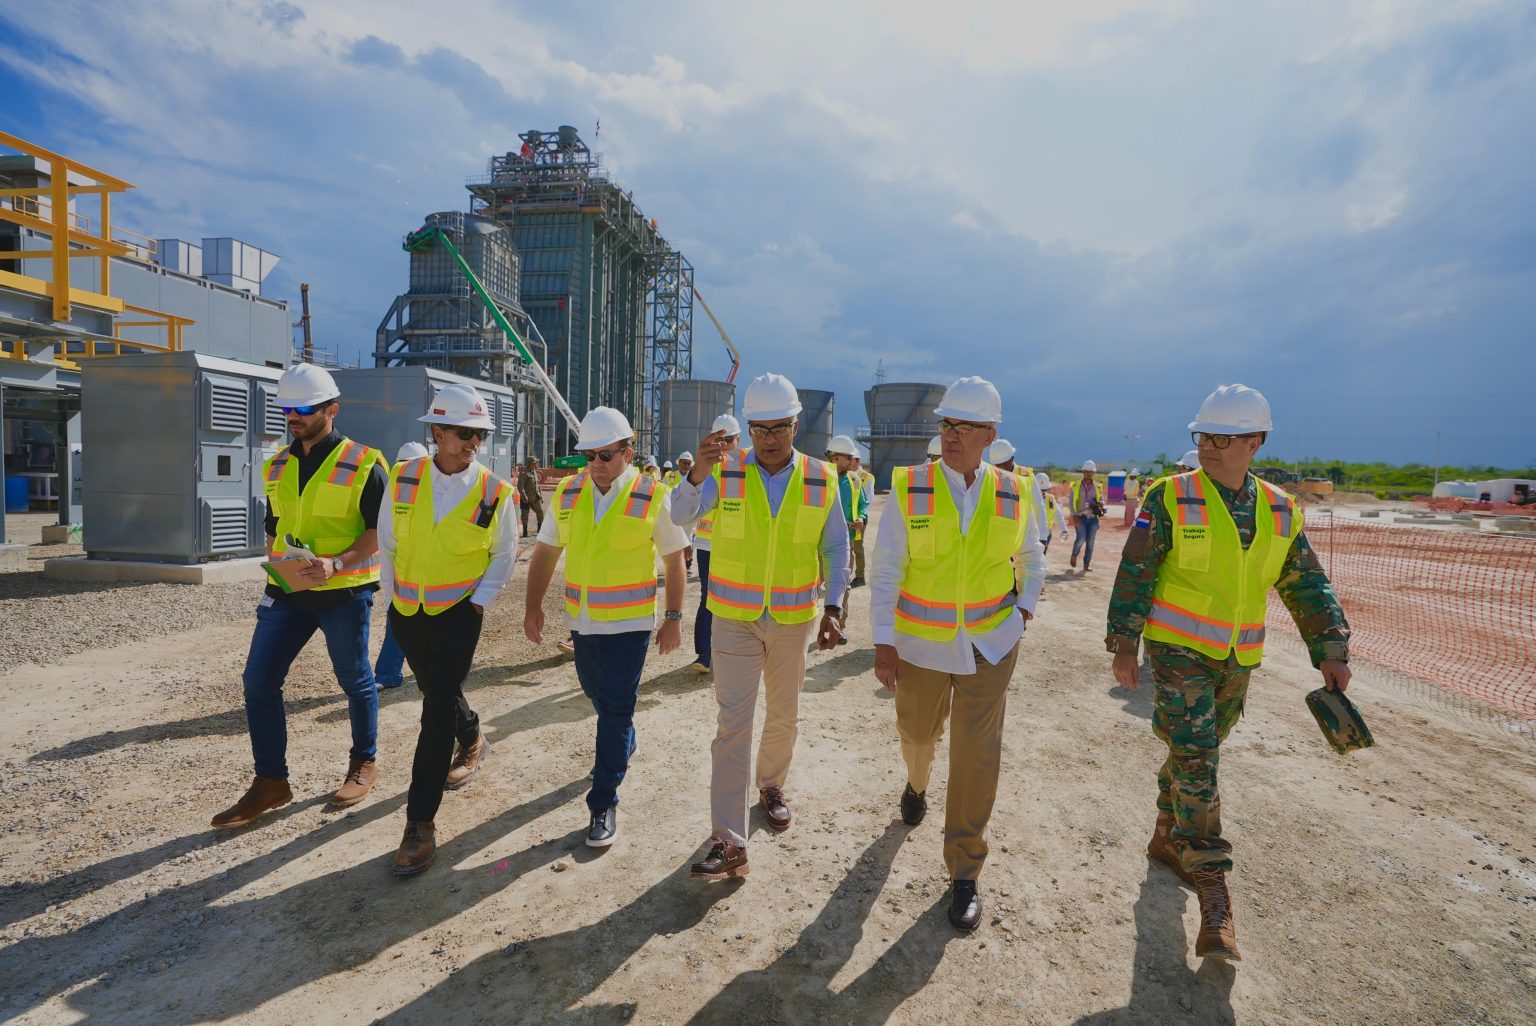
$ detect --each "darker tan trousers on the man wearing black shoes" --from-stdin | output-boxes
[895,645,1018,880]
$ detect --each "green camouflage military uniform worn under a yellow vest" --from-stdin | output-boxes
[1104,476,1349,872]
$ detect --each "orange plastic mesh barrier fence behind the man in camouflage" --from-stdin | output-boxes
[1269,510,1536,719]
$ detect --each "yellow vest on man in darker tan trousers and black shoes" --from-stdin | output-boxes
[891,464,1032,640]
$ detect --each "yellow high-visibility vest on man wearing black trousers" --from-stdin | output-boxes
[389,456,518,616]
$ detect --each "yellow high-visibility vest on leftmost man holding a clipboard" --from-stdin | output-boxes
[261,438,389,591]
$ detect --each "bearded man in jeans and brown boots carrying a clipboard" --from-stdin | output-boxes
[214,364,387,829]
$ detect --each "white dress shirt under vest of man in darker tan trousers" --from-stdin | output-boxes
[869,459,1046,674]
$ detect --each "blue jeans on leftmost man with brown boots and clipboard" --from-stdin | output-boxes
[244,591,379,779]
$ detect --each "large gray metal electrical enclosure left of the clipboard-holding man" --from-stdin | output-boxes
[80,352,287,564]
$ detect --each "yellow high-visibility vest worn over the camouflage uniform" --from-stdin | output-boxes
[1141,470,1303,667]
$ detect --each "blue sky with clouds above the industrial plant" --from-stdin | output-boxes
[0,0,1536,467]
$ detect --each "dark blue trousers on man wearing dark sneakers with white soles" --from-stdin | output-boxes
[571,631,651,813]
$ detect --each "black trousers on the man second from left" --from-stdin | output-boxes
[389,599,485,822]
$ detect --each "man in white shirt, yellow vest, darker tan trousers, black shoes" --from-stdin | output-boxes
[869,378,1044,931]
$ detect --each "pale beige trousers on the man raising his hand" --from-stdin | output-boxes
[710,616,816,845]
